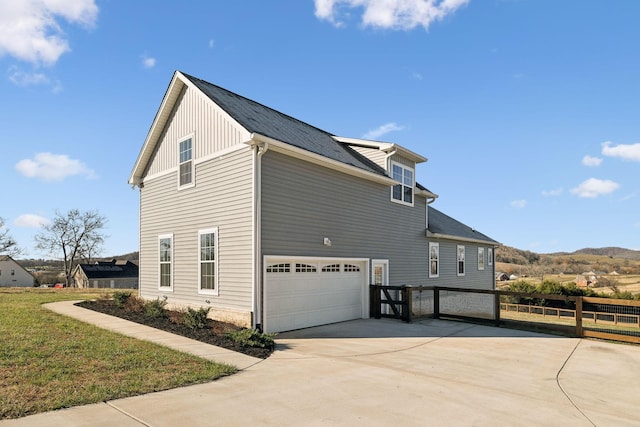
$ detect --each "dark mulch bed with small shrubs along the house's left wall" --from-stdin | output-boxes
[76,299,273,359]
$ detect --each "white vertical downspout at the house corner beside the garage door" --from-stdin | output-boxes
[253,142,269,331]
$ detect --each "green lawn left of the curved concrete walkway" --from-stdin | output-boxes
[0,288,235,419]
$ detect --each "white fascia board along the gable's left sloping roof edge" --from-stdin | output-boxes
[129,71,186,185]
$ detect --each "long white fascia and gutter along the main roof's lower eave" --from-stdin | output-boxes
[245,133,397,186]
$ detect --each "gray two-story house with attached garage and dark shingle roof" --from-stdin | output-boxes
[129,72,498,332]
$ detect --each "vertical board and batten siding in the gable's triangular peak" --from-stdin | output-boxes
[146,89,251,175]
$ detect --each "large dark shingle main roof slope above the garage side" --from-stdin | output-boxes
[182,73,386,175]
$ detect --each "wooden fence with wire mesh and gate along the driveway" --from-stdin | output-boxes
[370,285,640,343]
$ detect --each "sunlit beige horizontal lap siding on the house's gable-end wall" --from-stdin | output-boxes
[140,146,253,318]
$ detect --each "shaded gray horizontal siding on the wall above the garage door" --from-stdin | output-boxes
[262,151,428,285]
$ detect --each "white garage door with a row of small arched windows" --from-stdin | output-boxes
[264,257,367,332]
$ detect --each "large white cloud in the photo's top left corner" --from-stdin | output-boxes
[0,0,98,66]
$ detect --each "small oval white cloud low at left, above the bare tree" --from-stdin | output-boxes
[16,153,95,181]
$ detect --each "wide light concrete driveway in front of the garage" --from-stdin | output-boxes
[2,319,640,426]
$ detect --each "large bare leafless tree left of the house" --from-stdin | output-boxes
[35,209,106,286]
